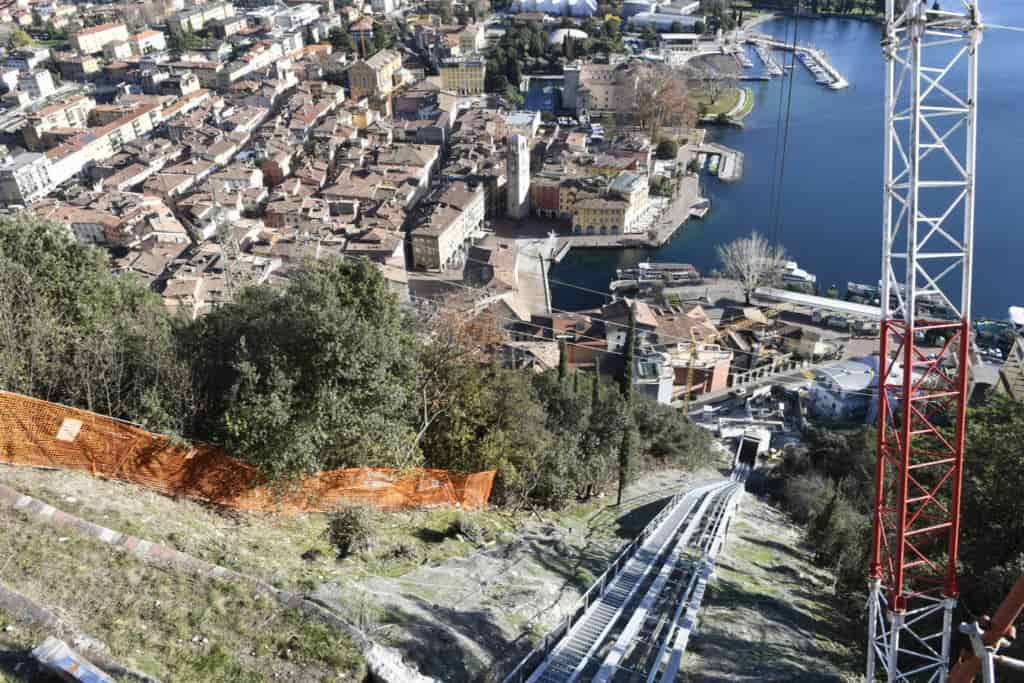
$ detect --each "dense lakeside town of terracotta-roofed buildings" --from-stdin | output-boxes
[0,0,1020,436]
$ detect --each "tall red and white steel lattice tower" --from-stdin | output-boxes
[866,0,982,682]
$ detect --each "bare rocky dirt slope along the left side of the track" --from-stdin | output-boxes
[317,462,722,681]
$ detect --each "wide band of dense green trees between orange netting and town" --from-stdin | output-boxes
[0,218,707,507]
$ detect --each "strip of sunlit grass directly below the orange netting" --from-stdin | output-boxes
[0,467,516,592]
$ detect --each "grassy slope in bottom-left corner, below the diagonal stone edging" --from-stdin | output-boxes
[0,510,366,683]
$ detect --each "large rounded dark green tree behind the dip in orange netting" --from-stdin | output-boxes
[189,259,420,477]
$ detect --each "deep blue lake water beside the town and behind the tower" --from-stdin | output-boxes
[551,0,1024,318]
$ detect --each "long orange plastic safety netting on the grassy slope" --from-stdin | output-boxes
[0,391,495,514]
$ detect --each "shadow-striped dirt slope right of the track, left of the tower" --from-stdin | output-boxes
[683,494,861,683]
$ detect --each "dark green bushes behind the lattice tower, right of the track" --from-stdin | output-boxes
[770,397,1024,635]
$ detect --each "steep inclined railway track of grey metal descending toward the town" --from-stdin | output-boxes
[504,470,745,683]
